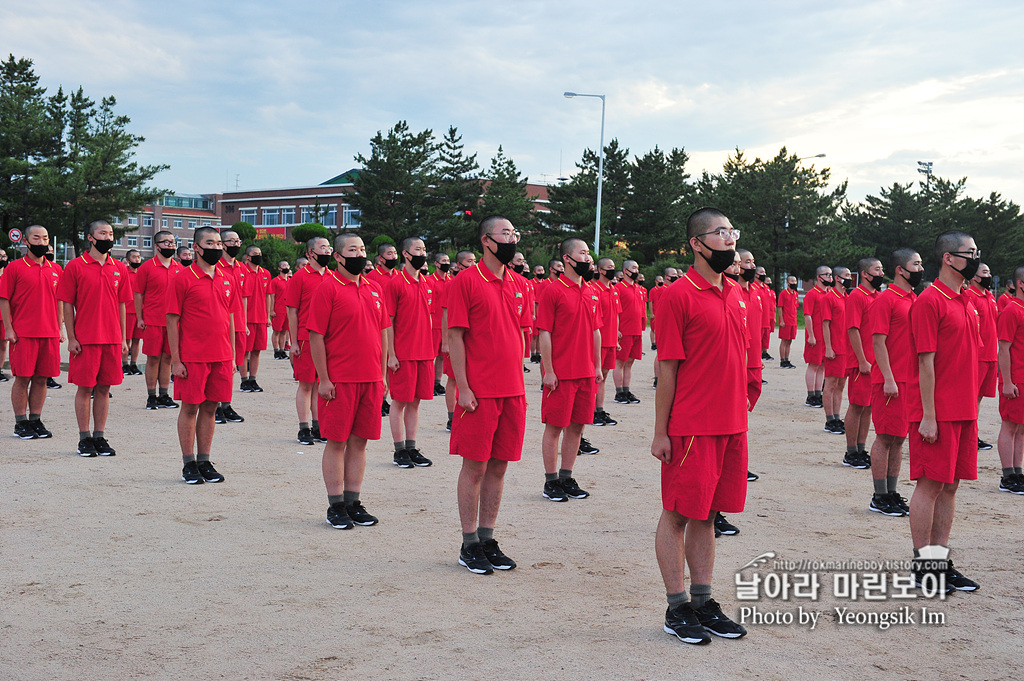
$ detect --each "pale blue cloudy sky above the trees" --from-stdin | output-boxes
[0,0,1024,204]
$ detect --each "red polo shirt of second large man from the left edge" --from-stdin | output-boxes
[57,252,134,345]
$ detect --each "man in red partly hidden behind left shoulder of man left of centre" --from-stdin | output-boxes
[285,237,329,444]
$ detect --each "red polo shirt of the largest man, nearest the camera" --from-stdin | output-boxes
[657,267,746,437]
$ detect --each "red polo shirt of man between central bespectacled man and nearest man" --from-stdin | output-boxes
[537,276,601,380]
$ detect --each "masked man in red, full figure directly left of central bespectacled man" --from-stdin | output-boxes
[307,232,391,529]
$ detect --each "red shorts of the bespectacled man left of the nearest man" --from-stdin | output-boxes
[450,395,526,461]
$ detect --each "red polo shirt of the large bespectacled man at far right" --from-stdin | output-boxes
[907,280,981,422]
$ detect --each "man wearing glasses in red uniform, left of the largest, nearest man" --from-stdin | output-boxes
[447,215,531,574]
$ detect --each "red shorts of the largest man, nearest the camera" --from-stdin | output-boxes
[662,433,746,520]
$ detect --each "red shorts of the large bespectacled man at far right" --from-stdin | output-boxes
[907,421,978,482]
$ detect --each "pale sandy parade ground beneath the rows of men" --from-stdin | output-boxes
[0,339,1024,681]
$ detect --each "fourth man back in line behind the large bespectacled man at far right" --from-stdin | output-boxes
[814,267,853,435]
